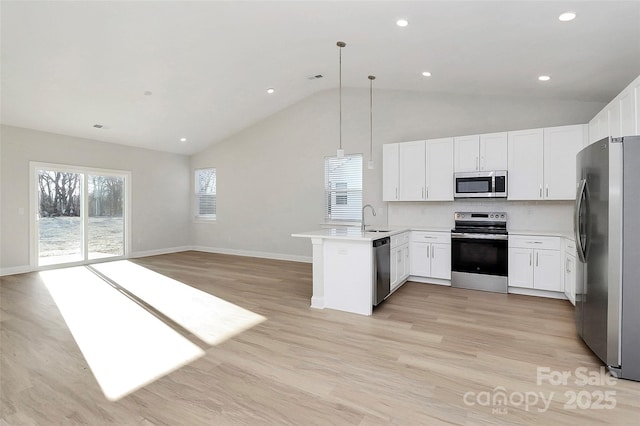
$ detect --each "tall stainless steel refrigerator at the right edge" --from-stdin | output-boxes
[574,136,640,380]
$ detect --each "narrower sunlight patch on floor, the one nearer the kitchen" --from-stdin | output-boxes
[91,260,266,345]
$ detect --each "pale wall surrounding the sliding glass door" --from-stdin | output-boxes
[0,126,191,273]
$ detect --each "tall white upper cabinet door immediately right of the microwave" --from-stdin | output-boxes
[507,129,543,200]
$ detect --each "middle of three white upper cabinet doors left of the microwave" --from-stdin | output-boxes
[399,141,426,201]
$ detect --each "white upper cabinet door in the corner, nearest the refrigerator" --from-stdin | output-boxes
[543,124,587,200]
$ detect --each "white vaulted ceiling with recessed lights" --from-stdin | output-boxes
[0,0,640,154]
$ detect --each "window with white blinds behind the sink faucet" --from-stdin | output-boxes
[324,154,362,222]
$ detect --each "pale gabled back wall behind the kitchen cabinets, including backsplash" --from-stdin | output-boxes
[191,89,603,258]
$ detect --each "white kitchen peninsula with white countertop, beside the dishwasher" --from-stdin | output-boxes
[292,228,408,315]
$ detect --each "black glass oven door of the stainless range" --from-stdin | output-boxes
[451,232,508,277]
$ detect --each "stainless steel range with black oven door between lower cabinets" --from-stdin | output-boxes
[451,212,509,293]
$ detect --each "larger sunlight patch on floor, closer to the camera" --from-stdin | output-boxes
[40,267,204,401]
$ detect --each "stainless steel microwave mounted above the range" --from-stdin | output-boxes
[453,170,507,198]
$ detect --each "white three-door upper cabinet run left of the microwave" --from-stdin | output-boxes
[382,138,453,201]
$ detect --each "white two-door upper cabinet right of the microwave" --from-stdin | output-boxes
[507,124,587,200]
